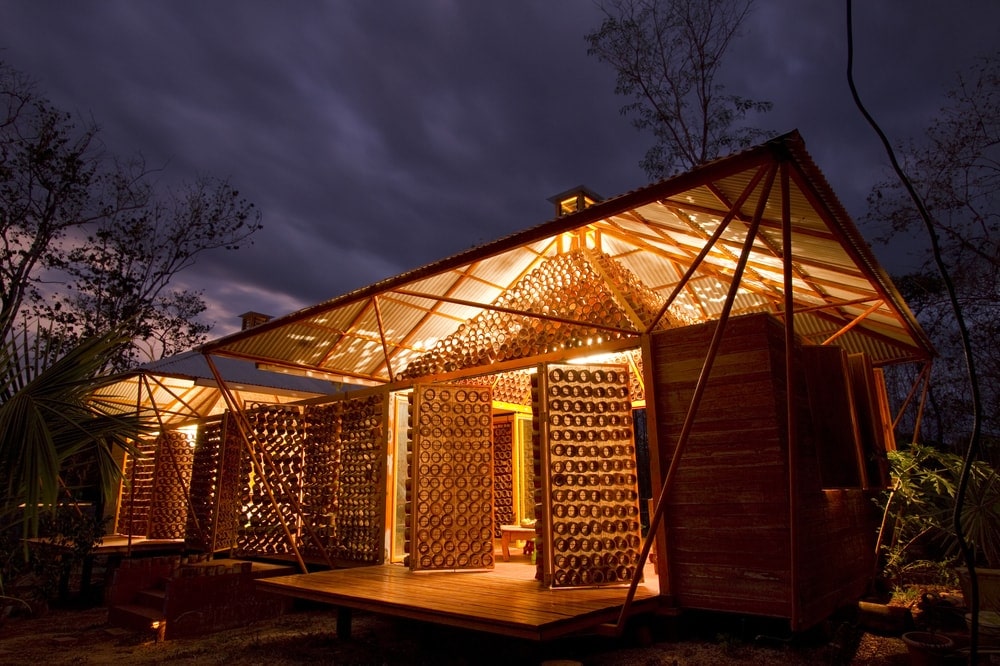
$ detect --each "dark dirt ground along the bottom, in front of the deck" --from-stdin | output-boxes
[0,605,936,666]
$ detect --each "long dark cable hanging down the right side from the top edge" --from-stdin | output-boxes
[847,0,982,652]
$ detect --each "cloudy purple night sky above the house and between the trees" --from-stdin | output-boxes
[0,0,1000,336]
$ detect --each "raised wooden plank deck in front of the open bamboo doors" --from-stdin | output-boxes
[257,563,660,641]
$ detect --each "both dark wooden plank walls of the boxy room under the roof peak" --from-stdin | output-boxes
[651,315,874,630]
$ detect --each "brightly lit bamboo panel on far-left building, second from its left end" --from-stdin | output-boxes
[146,430,194,539]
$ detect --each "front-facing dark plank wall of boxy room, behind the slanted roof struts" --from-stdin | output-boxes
[652,315,791,616]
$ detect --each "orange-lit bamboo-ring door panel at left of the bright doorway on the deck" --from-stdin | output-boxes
[408,384,494,571]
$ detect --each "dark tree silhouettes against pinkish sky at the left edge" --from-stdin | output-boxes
[0,62,261,370]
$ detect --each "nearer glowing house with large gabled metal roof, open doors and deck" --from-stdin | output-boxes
[111,132,933,638]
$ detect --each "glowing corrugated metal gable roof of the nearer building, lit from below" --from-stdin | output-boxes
[206,132,933,383]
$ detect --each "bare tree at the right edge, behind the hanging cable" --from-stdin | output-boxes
[868,52,1000,455]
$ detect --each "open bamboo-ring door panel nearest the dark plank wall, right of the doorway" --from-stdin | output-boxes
[534,364,642,587]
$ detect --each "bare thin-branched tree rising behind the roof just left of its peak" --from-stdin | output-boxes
[587,0,771,179]
